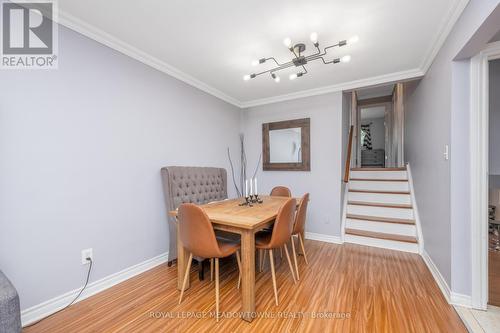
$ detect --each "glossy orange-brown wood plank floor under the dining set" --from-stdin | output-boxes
[24,240,466,333]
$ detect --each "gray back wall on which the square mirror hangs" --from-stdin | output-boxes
[244,92,342,236]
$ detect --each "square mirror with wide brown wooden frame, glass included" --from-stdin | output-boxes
[262,118,311,171]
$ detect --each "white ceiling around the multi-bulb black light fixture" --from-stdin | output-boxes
[59,0,468,107]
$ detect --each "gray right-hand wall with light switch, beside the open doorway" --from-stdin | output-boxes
[405,0,499,295]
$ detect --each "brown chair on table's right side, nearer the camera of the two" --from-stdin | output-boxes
[255,199,297,305]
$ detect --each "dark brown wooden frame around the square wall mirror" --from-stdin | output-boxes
[262,118,311,171]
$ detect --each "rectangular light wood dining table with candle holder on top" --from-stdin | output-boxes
[169,196,300,322]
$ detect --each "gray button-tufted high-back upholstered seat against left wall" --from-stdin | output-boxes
[161,166,232,277]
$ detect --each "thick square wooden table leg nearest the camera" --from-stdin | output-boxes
[241,230,255,322]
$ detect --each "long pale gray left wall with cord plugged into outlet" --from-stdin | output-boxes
[0,27,241,309]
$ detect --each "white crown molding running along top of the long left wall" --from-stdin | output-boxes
[57,10,241,107]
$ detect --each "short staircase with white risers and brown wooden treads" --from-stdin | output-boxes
[344,168,419,253]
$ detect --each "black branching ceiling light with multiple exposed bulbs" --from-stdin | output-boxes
[243,32,359,82]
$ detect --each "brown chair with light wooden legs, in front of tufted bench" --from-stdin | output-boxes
[178,203,241,321]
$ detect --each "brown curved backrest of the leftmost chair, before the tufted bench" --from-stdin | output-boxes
[178,203,221,258]
